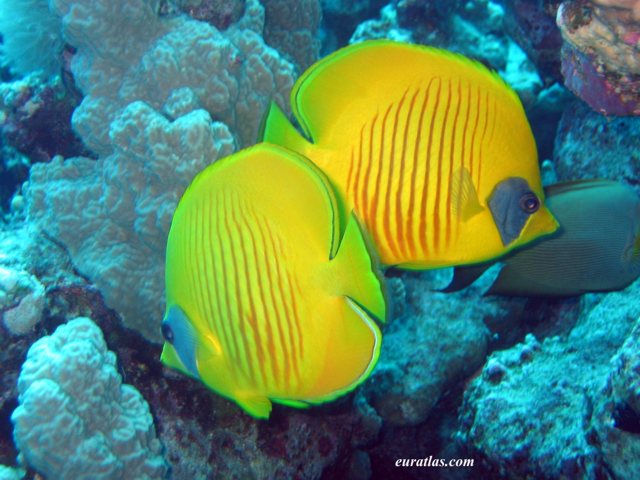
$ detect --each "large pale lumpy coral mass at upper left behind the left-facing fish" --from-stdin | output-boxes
[27,0,293,341]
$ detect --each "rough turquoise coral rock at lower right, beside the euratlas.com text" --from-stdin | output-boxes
[460,282,640,478]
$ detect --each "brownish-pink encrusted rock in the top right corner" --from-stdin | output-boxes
[557,0,640,115]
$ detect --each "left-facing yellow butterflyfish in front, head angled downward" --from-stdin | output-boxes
[161,144,385,418]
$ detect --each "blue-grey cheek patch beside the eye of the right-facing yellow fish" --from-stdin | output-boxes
[489,177,531,246]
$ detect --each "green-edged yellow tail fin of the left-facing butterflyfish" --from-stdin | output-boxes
[332,212,386,323]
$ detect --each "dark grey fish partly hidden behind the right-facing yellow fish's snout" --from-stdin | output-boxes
[443,180,640,297]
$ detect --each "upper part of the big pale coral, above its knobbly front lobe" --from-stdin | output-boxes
[54,0,292,155]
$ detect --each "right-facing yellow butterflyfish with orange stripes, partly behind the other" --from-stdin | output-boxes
[264,40,557,268]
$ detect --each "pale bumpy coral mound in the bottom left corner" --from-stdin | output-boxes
[11,318,167,480]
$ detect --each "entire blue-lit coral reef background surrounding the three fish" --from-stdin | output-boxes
[0,0,640,480]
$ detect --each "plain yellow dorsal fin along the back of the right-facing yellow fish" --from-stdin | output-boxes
[291,40,522,143]
